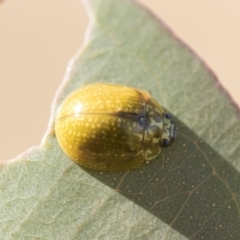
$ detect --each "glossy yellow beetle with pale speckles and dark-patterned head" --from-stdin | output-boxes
[55,83,176,171]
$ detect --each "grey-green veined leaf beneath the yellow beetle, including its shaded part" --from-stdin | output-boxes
[0,0,240,240]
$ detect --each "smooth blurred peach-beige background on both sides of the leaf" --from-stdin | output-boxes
[0,0,240,160]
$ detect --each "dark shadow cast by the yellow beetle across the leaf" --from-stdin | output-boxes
[84,117,240,239]
